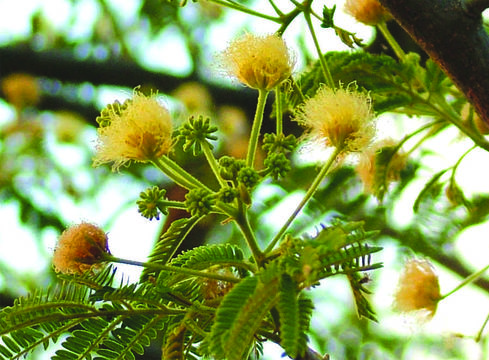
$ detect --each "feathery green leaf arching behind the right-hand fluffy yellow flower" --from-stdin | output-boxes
[289,52,450,115]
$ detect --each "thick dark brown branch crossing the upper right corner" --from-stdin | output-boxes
[380,0,489,123]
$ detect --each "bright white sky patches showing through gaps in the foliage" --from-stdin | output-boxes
[0,0,489,359]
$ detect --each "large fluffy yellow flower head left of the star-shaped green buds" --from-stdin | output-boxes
[93,92,173,170]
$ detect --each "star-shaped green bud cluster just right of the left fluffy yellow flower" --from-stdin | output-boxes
[178,115,217,156]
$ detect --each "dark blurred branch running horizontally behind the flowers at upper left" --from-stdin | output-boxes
[0,45,256,119]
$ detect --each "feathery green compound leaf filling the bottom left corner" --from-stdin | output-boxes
[0,266,182,360]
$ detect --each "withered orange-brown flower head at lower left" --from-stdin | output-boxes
[53,223,109,274]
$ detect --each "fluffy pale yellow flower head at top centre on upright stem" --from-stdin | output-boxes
[221,34,294,91]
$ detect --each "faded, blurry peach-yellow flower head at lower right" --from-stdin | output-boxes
[394,259,441,317]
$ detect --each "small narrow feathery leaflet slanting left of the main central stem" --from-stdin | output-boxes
[141,216,202,280]
